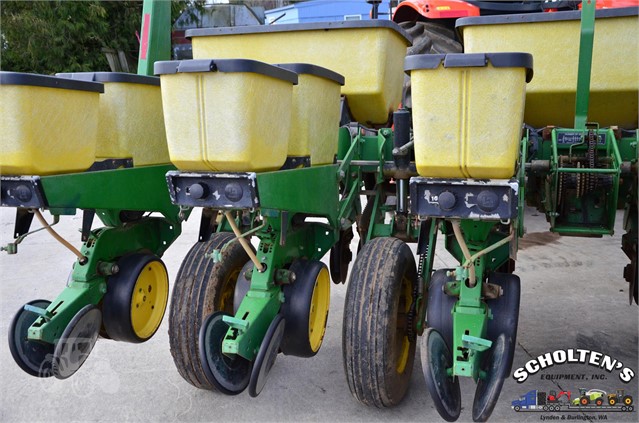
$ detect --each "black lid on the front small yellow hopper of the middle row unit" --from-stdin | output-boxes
[153,59,297,84]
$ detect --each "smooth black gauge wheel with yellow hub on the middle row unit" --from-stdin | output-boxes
[281,260,331,357]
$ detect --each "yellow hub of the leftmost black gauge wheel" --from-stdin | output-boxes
[131,261,169,339]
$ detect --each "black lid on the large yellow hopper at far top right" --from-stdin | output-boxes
[455,7,639,31]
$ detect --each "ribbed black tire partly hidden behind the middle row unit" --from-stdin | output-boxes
[169,232,254,390]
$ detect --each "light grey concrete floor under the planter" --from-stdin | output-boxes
[0,209,639,422]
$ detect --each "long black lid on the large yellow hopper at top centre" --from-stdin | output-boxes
[185,19,413,45]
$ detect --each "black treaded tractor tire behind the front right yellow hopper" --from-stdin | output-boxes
[399,21,463,109]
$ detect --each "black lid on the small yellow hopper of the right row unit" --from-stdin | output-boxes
[404,53,533,82]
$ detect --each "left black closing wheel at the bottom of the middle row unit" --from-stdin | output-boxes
[198,311,252,395]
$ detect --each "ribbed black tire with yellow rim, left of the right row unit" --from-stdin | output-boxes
[342,238,417,408]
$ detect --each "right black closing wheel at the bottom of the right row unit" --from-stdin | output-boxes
[473,333,514,422]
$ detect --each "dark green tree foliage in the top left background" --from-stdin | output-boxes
[0,0,186,74]
